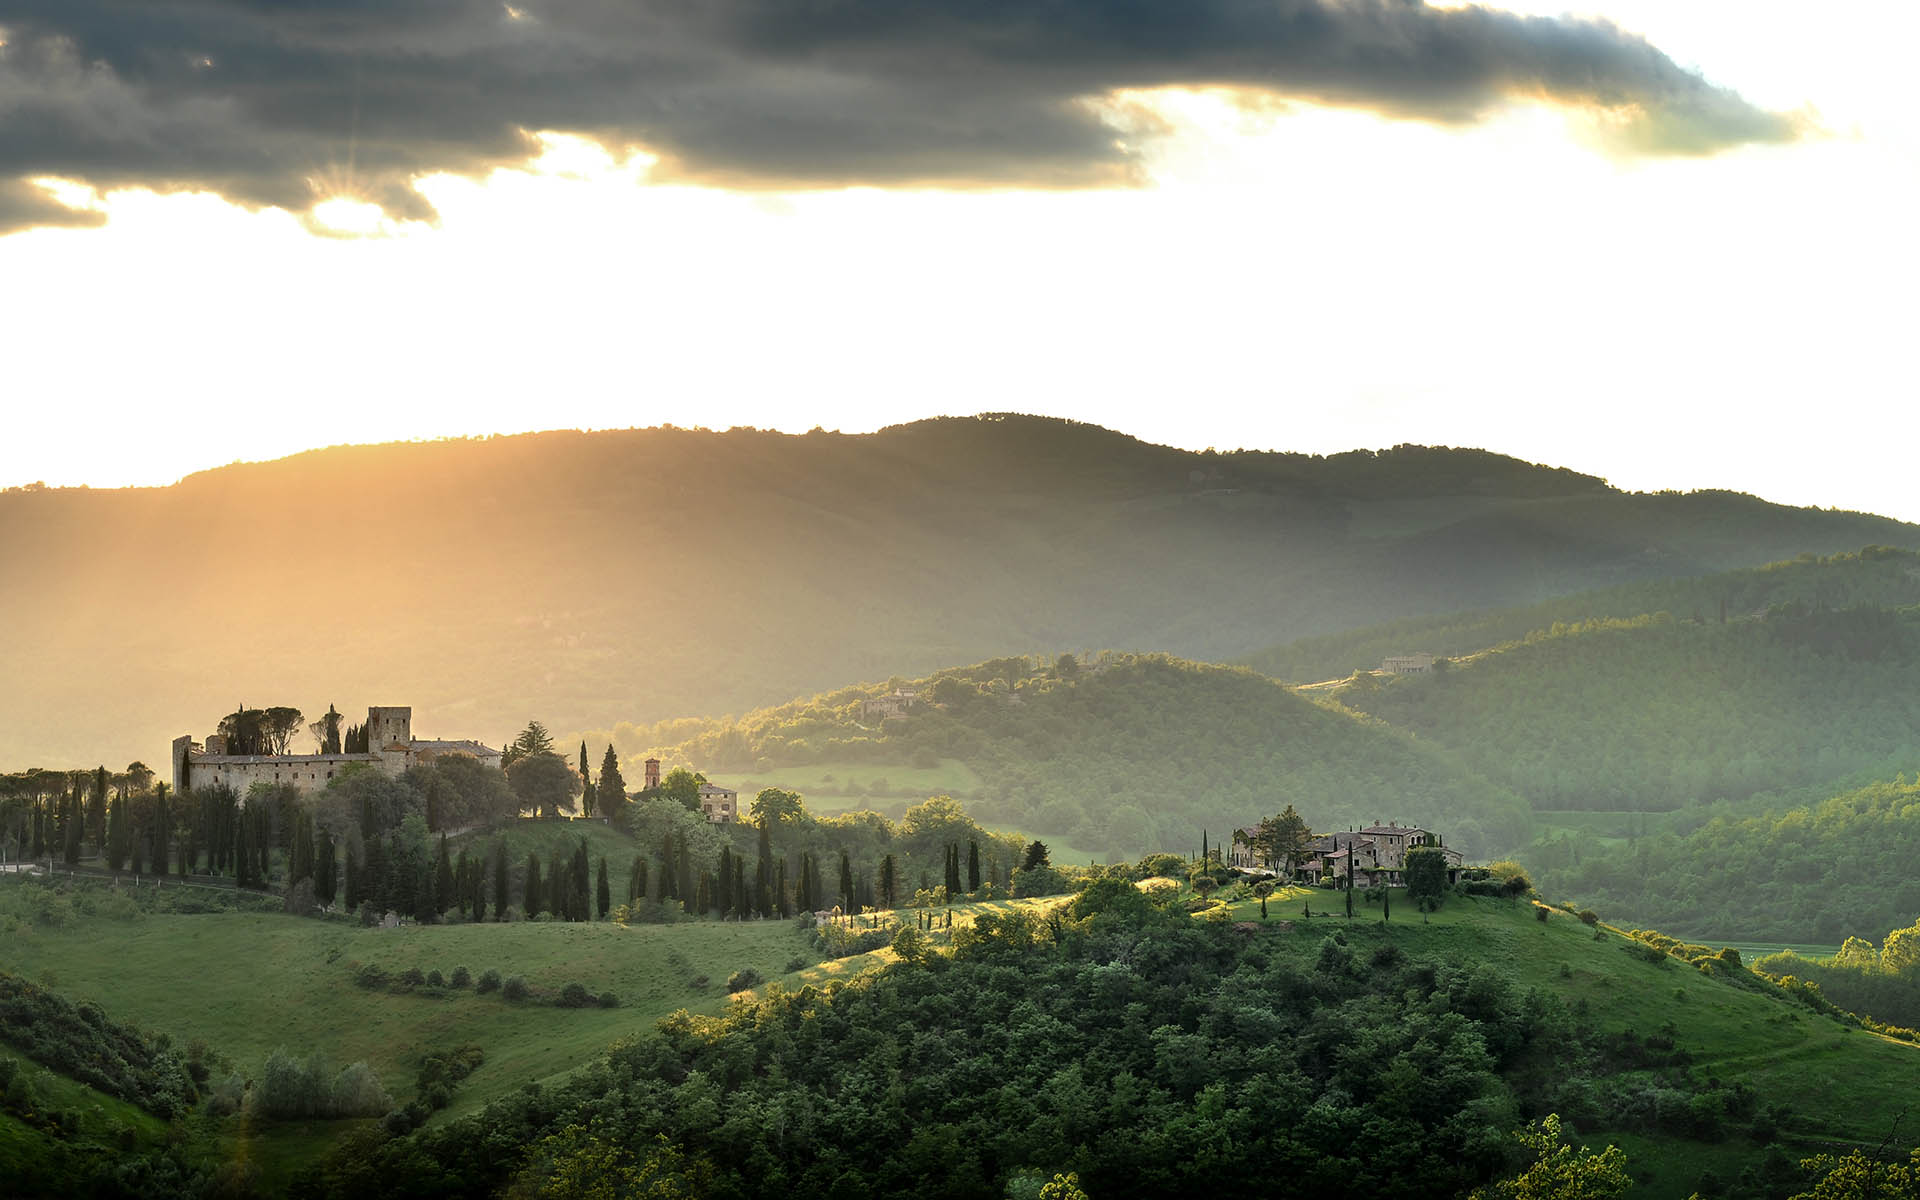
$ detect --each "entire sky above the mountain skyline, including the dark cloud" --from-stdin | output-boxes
[0,0,1920,520]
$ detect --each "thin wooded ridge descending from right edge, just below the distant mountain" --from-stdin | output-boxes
[1244,545,1920,684]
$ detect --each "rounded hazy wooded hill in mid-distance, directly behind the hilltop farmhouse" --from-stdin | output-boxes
[595,655,1528,856]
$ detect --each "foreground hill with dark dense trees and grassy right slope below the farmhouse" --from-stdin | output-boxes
[298,890,1920,1200]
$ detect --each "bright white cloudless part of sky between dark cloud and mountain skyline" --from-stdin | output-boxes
[0,0,1920,520]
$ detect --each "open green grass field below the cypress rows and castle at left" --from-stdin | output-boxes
[0,902,816,1112]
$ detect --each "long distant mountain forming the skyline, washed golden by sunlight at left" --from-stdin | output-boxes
[0,417,1920,766]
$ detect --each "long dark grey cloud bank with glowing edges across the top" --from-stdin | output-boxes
[0,0,1795,230]
